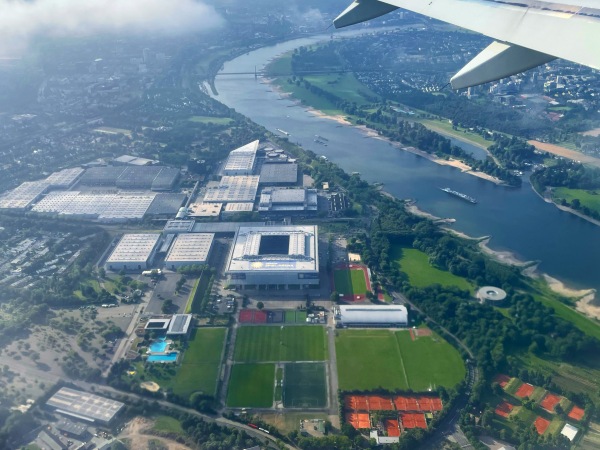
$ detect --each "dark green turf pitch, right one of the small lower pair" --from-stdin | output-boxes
[283,363,327,408]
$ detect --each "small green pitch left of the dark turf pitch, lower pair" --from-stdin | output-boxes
[227,364,275,408]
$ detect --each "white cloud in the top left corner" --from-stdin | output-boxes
[0,0,223,55]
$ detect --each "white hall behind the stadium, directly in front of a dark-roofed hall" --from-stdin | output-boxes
[258,188,318,215]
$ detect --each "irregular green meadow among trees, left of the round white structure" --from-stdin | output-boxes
[392,246,474,292]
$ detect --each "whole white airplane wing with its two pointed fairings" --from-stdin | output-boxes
[333,0,600,89]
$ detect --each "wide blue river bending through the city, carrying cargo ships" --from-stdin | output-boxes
[215,31,600,292]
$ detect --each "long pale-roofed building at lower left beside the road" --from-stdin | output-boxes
[46,387,125,425]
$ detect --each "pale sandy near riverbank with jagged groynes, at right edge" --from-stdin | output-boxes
[405,202,600,319]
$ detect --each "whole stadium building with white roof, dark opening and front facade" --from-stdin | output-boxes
[226,225,319,289]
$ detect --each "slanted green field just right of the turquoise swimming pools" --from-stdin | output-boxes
[172,328,226,398]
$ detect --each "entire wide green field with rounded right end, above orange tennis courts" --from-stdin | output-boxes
[336,330,465,392]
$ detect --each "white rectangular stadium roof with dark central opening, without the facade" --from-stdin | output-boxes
[227,225,319,272]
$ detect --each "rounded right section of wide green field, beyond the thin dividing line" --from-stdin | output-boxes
[396,331,466,392]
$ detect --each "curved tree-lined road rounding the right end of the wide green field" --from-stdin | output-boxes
[392,292,479,450]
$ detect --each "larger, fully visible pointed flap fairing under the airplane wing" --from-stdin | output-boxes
[450,41,556,89]
